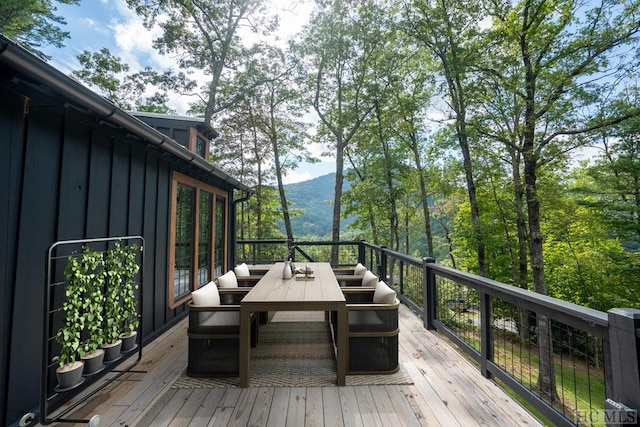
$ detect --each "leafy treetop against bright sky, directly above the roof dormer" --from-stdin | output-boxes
[127,0,275,123]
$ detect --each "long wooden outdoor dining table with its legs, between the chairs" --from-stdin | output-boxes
[239,262,348,388]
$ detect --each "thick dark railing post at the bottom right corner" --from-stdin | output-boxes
[605,308,640,425]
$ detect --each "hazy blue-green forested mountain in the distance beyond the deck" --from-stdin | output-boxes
[278,173,353,239]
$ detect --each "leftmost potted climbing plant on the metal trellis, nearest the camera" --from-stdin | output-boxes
[53,252,85,392]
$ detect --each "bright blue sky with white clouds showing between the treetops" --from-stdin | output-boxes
[42,0,335,183]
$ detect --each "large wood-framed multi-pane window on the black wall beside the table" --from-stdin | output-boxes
[169,172,227,308]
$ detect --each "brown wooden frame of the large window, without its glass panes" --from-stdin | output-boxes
[167,172,229,309]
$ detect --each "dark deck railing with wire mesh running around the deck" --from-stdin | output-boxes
[237,240,640,425]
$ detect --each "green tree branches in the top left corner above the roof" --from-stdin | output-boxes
[0,0,80,59]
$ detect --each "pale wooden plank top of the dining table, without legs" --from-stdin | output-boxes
[242,262,345,310]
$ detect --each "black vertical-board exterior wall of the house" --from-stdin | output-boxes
[0,76,233,425]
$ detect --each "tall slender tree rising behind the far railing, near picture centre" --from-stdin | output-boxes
[299,0,381,264]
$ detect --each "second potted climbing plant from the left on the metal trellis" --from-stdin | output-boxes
[75,247,105,375]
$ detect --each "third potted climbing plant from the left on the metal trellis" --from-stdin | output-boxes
[101,243,122,362]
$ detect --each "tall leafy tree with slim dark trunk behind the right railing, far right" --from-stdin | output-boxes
[485,0,640,403]
